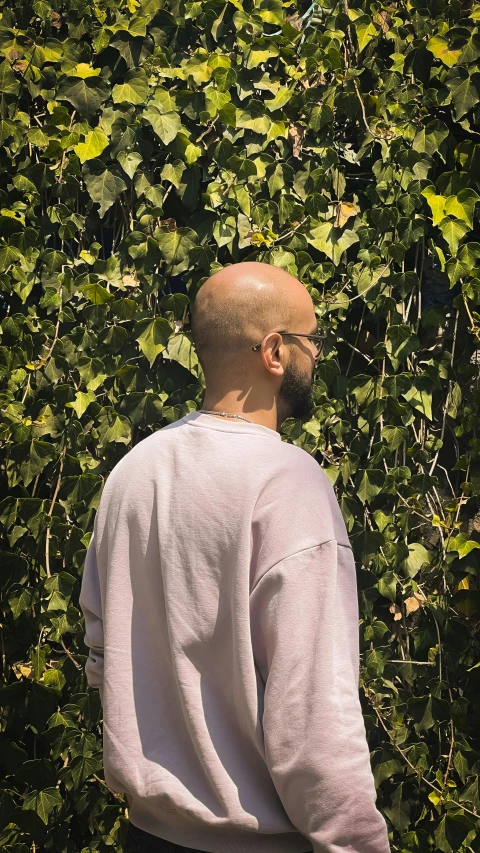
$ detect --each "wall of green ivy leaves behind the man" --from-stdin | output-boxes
[0,0,480,853]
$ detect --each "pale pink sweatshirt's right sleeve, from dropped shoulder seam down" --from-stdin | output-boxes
[250,540,390,853]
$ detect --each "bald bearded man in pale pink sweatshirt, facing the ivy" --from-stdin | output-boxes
[80,263,390,853]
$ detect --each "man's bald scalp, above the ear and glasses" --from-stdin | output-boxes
[191,261,314,381]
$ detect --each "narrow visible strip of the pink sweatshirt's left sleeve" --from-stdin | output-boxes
[79,533,104,703]
